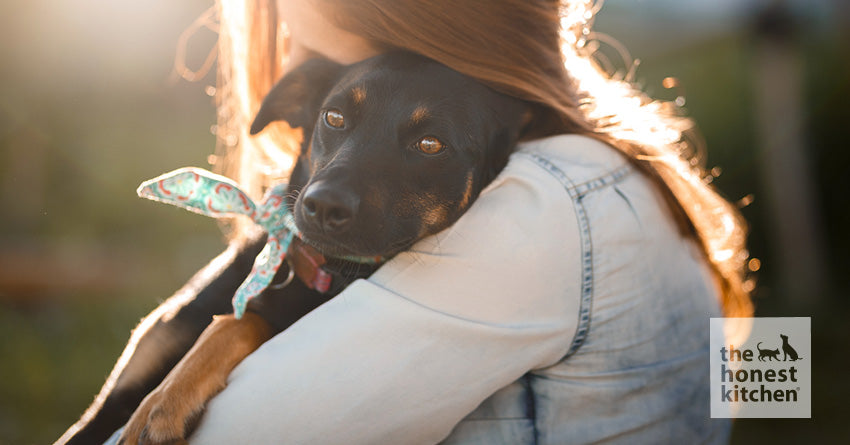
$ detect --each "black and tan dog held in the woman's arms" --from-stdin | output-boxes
[59,53,529,444]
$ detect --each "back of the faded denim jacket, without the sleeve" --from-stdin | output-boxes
[443,140,730,445]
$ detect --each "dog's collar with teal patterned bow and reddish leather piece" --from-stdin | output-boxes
[136,167,383,319]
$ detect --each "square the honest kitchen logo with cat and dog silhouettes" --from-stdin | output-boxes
[709,317,812,418]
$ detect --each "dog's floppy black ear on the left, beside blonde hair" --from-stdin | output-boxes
[251,59,344,134]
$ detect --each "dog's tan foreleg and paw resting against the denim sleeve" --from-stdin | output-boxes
[119,312,273,445]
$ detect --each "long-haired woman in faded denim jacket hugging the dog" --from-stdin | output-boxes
[116,0,751,444]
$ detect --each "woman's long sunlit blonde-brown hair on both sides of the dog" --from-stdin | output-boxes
[202,0,753,317]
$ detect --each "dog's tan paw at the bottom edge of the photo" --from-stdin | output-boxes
[118,388,195,445]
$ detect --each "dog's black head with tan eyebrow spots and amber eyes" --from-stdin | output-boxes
[251,53,527,256]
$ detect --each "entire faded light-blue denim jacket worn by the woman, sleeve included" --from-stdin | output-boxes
[181,135,729,444]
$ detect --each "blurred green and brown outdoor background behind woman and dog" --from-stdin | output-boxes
[0,0,850,444]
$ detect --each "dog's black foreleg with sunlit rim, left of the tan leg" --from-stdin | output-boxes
[56,238,262,445]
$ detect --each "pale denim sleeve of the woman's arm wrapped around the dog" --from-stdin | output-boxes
[191,151,581,444]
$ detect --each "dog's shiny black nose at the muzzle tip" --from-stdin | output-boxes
[301,181,360,233]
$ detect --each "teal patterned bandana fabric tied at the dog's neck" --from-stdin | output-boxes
[136,167,298,318]
